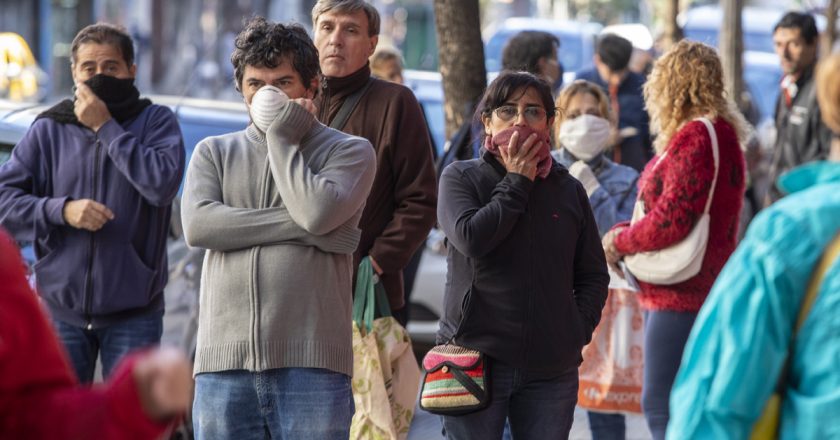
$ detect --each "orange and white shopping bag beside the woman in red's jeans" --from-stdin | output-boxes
[578,289,644,414]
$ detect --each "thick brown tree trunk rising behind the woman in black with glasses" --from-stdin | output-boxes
[435,0,487,138]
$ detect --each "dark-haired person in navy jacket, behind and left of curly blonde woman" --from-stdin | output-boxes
[577,34,653,172]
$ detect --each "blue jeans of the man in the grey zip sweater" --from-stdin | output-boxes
[193,368,355,440]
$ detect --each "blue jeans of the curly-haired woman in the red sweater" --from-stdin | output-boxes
[642,310,697,440]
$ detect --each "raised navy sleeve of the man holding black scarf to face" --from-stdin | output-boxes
[96,106,185,206]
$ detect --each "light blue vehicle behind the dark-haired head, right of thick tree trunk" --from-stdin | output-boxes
[484,17,602,84]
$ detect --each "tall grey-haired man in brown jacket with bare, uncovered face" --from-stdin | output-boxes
[312,0,437,319]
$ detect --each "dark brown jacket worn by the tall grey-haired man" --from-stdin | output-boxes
[315,65,437,310]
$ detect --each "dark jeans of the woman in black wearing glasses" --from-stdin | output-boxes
[442,360,578,440]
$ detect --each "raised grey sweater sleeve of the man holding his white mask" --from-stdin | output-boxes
[266,102,376,235]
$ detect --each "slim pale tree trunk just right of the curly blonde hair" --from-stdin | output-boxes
[718,0,746,110]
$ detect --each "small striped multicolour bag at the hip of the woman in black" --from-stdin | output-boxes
[420,344,490,416]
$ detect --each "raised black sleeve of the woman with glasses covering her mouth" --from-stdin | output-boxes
[438,164,532,258]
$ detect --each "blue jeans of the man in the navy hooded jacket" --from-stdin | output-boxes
[53,313,163,383]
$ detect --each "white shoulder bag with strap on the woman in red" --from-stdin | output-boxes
[624,118,720,285]
